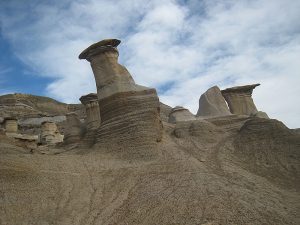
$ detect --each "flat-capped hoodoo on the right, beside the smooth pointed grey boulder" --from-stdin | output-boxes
[221,84,260,115]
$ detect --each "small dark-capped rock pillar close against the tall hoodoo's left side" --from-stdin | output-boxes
[80,93,101,147]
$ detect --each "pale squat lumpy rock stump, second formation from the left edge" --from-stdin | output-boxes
[39,121,64,145]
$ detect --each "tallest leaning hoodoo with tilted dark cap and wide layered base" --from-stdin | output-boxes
[79,39,162,149]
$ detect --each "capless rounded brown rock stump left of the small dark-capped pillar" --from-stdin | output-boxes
[64,113,84,145]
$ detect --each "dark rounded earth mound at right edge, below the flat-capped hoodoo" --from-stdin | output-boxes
[234,118,300,185]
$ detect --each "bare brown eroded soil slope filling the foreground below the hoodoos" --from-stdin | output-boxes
[0,116,300,225]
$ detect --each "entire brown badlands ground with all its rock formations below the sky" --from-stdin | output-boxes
[0,39,300,225]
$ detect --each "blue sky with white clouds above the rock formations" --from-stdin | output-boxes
[0,0,300,128]
